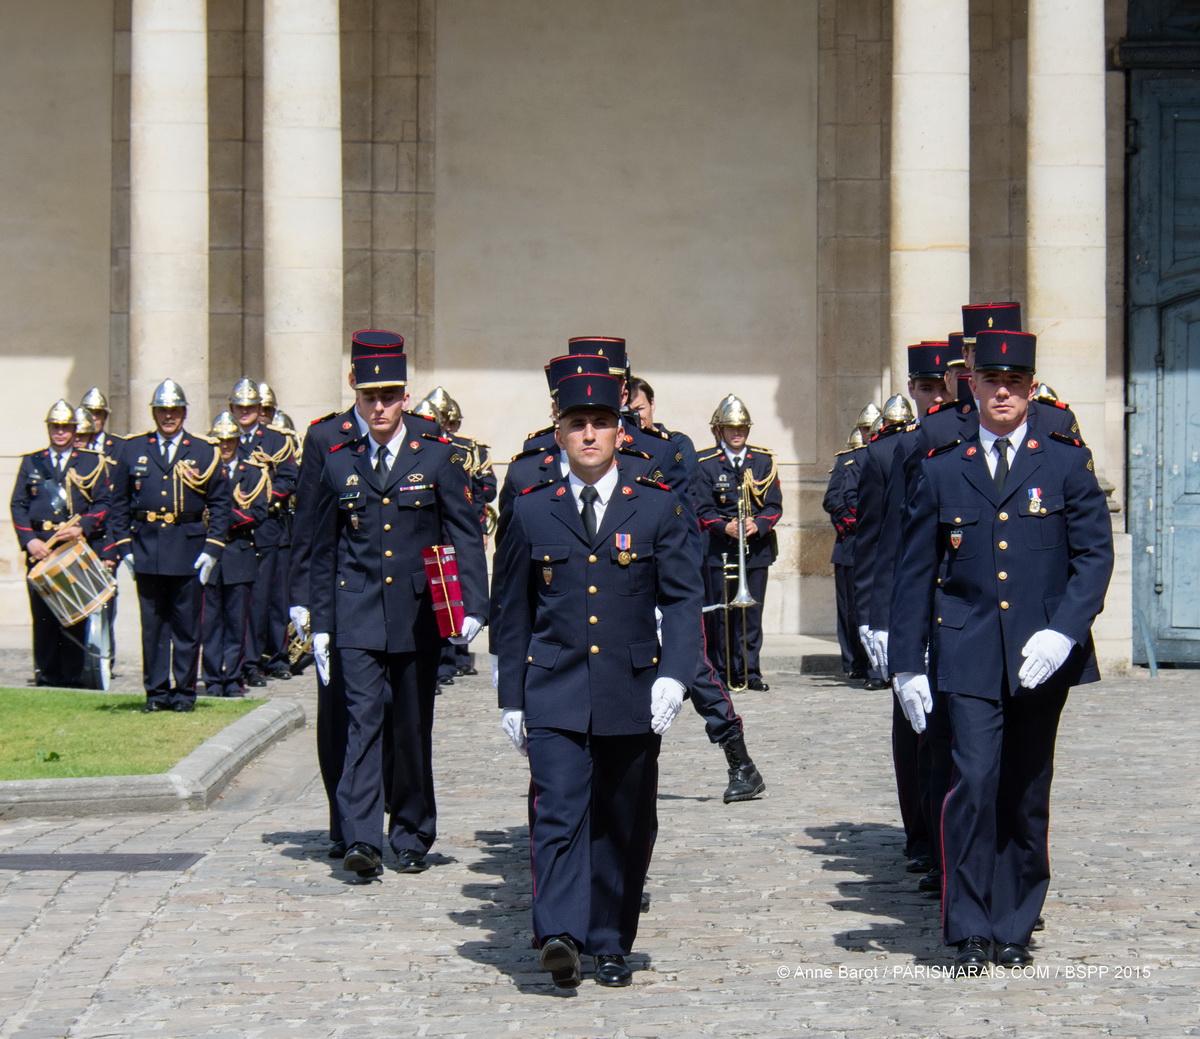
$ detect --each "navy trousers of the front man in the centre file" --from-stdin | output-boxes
[528,728,662,956]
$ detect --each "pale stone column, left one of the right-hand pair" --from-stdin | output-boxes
[883,0,971,388]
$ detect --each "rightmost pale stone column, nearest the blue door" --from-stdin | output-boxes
[1025,0,1108,468]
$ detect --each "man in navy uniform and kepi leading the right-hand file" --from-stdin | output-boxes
[889,331,1112,973]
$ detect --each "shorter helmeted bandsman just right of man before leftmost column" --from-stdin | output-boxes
[202,412,271,697]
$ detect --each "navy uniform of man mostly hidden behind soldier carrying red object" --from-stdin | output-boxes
[288,407,438,843]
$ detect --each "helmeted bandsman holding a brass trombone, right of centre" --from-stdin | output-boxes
[691,394,784,692]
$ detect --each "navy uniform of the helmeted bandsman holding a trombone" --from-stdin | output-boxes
[691,444,784,681]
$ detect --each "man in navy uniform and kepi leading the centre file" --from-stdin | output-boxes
[497,374,701,987]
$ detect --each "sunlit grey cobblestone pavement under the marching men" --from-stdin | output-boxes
[0,657,1200,1039]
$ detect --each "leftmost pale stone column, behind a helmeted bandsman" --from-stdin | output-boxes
[130,0,211,419]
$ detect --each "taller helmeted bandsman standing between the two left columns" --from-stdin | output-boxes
[229,379,298,686]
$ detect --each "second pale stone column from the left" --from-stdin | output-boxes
[263,0,346,424]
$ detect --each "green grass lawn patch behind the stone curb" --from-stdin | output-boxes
[0,689,265,780]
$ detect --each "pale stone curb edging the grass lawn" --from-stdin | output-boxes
[0,699,306,819]
